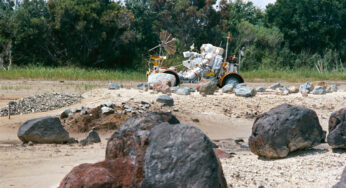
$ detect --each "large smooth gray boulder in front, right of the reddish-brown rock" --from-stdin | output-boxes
[141,123,226,188]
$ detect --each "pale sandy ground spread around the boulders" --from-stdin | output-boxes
[0,81,346,187]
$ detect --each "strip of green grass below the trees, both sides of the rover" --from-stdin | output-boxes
[0,65,346,81]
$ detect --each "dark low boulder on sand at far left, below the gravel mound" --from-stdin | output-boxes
[18,116,69,144]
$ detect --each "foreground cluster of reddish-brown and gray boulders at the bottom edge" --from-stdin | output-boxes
[60,112,226,187]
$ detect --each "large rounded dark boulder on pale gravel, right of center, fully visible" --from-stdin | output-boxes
[249,104,325,158]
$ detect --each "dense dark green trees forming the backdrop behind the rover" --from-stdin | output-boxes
[0,0,346,72]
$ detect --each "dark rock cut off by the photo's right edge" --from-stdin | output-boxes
[327,108,346,148]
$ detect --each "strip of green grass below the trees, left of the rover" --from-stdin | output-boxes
[0,66,146,81]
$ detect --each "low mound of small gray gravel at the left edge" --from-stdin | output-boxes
[0,93,82,117]
